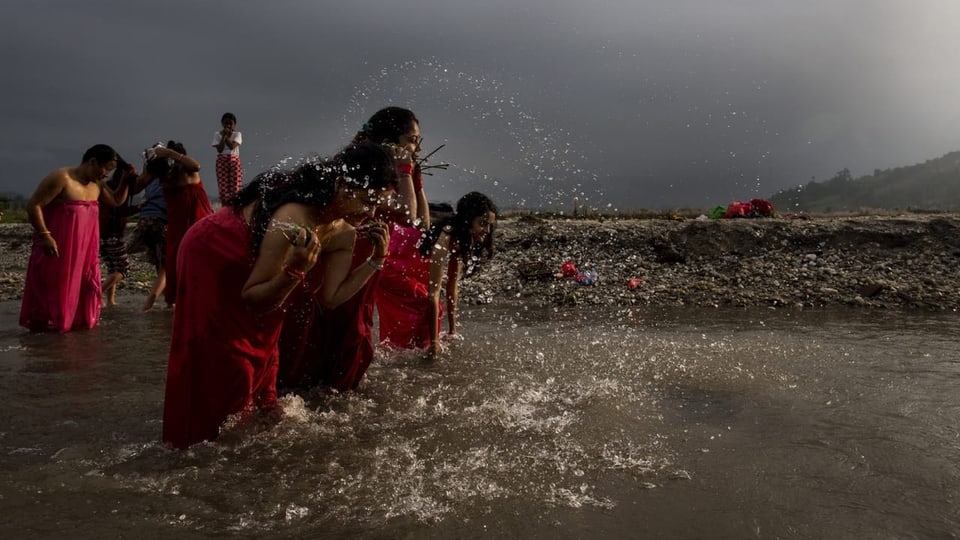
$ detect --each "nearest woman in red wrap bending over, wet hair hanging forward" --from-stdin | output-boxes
[163,144,395,448]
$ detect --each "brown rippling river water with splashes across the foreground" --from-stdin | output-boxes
[0,297,960,540]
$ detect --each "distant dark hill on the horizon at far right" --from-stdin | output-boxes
[770,151,960,212]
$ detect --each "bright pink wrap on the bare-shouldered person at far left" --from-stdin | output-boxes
[20,201,102,332]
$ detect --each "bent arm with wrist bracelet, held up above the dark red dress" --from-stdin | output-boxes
[314,223,390,309]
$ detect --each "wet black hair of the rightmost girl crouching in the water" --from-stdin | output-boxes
[420,191,499,275]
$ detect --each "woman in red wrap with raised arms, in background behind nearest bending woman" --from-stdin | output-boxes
[137,141,213,306]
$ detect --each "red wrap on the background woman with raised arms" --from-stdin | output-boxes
[163,184,213,304]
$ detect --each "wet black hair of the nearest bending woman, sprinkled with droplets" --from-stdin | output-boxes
[229,142,397,253]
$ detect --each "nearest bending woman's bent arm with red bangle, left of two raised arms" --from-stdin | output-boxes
[241,204,320,313]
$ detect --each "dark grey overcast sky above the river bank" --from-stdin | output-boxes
[0,0,960,210]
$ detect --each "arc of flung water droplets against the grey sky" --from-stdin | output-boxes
[343,58,602,210]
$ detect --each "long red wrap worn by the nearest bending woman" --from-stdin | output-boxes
[163,208,284,448]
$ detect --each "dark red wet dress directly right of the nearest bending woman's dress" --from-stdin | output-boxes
[278,236,378,392]
